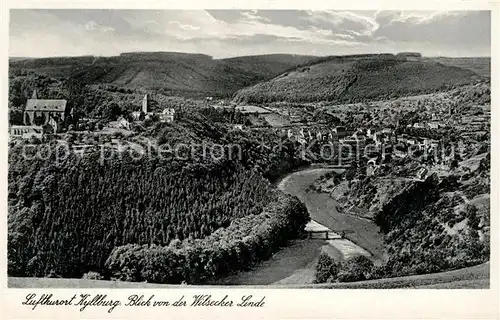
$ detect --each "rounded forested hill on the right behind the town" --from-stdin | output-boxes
[235,55,480,103]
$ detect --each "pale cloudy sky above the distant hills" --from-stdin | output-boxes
[9,9,491,58]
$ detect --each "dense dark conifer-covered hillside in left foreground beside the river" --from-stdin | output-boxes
[8,110,309,283]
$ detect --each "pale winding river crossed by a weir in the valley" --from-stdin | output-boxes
[213,168,383,285]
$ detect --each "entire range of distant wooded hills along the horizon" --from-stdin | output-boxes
[9,51,490,99]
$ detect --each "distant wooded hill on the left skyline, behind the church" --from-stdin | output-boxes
[9,52,315,97]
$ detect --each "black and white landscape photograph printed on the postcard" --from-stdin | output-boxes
[4,7,492,292]
